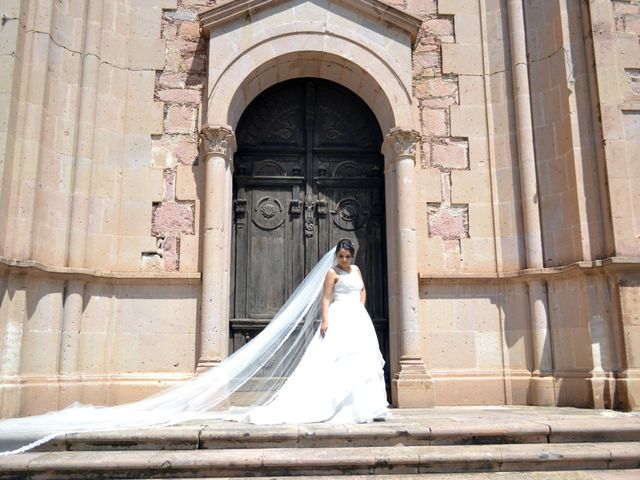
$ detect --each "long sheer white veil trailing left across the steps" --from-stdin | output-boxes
[0,248,335,455]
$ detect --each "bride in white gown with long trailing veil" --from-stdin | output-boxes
[0,239,387,454]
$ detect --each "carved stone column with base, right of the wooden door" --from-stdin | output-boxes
[383,128,433,407]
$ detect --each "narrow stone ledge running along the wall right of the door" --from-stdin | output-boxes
[418,257,640,283]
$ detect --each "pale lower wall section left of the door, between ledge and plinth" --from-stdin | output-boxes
[0,274,200,376]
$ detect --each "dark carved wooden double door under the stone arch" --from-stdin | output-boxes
[230,78,388,372]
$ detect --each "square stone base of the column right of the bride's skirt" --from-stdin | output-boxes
[391,359,435,408]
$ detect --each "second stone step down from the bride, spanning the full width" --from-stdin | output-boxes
[0,442,640,479]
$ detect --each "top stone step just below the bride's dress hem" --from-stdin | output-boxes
[38,417,640,451]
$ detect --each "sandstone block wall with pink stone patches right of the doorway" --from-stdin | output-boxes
[406,0,640,406]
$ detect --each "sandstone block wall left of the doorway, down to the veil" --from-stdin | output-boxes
[0,0,208,415]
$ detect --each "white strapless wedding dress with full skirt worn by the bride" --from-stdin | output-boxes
[243,267,387,424]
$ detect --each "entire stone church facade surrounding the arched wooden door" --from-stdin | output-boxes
[0,0,640,415]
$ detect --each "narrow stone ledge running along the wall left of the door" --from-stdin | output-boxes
[0,257,201,285]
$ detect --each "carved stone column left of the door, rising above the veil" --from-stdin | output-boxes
[197,125,236,371]
